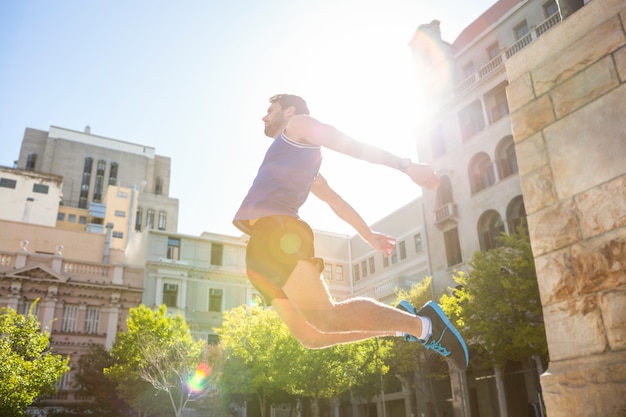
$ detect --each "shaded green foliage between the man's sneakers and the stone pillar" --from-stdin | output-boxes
[441,227,547,366]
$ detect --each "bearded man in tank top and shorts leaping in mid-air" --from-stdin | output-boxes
[233,94,469,370]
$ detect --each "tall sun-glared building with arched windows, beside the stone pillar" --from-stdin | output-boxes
[410,0,561,416]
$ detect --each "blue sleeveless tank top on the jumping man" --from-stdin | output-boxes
[233,133,322,233]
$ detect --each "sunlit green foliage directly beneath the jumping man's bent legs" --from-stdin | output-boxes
[218,306,390,414]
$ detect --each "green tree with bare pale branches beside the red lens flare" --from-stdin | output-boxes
[105,305,210,417]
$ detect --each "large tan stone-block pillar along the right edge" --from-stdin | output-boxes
[506,0,626,417]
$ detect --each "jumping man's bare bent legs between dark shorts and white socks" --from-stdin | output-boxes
[280,261,422,347]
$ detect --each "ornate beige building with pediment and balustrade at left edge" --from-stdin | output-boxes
[0,214,143,407]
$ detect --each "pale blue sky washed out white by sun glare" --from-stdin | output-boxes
[0,0,495,236]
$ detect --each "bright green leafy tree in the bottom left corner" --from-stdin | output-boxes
[0,308,69,417]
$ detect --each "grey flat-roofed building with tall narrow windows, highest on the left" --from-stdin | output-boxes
[17,126,178,236]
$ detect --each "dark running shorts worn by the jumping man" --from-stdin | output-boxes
[246,216,324,305]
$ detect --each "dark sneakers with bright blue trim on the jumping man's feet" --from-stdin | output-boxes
[396,300,469,371]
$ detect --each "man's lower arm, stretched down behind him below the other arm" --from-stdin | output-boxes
[311,175,396,256]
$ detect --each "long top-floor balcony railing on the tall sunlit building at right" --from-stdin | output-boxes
[454,12,561,96]
